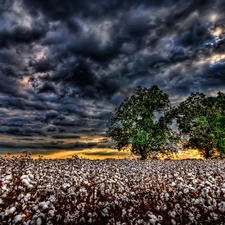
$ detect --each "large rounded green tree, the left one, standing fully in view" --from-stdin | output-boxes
[107,85,170,159]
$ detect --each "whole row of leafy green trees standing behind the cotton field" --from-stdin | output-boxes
[107,85,225,159]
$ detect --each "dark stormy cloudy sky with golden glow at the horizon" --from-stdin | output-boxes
[0,0,225,158]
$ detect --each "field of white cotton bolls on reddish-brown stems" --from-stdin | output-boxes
[0,157,225,225]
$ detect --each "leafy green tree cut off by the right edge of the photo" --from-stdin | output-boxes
[166,92,225,158]
